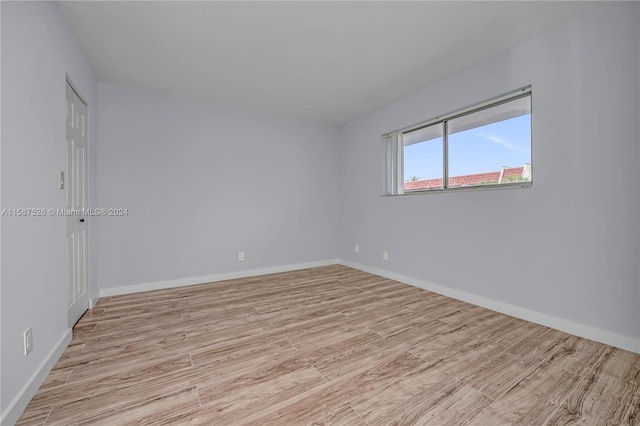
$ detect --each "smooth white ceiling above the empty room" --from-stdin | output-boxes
[62,1,596,125]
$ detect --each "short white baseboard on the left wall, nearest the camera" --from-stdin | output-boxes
[0,329,73,425]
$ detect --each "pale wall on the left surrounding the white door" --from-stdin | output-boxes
[0,1,96,424]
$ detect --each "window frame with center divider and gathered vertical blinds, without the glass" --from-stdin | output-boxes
[382,86,533,195]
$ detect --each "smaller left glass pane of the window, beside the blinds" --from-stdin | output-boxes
[402,123,443,191]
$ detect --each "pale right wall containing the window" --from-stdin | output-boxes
[339,3,640,350]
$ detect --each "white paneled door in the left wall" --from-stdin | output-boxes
[67,83,89,327]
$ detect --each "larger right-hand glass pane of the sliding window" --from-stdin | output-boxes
[448,96,531,188]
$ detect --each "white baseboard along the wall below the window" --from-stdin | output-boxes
[340,260,640,353]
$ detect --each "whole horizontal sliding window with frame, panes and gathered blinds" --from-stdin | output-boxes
[385,87,532,195]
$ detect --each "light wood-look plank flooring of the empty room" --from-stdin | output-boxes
[19,265,640,426]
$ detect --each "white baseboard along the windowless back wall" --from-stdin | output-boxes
[100,259,340,297]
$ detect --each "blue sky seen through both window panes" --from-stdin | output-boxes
[404,114,531,181]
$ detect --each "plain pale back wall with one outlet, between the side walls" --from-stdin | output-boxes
[97,83,338,292]
